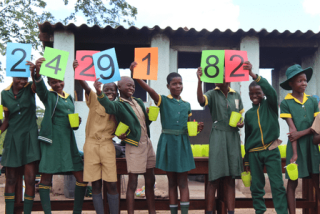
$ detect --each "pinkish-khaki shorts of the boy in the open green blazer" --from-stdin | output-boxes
[126,138,156,174]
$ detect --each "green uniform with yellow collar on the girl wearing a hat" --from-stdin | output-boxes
[280,93,320,178]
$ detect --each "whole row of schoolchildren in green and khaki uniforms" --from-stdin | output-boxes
[0,58,320,214]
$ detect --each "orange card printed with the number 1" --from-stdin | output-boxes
[133,47,158,80]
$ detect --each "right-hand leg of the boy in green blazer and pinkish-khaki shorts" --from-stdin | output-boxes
[144,168,156,214]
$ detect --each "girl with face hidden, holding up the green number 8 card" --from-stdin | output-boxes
[197,67,244,214]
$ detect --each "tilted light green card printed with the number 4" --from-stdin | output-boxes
[40,47,69,80]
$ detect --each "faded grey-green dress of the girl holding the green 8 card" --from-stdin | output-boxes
[204,87,244,181]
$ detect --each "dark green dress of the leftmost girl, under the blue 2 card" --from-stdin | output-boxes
[1,82,40,167]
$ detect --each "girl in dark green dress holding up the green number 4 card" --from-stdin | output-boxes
[35,58,87,214]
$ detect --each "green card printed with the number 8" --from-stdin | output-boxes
[201,50,224,83]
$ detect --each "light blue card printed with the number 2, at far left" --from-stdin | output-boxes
[6,43,32,77]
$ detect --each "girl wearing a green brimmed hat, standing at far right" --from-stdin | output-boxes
[280,65,320,214]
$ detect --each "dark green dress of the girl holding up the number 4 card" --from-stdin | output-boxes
[37,86,83,174]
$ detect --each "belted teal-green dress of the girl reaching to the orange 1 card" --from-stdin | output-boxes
[156,95,195,172]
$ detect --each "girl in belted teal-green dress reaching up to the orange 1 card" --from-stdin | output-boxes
[130,62,203,214]
